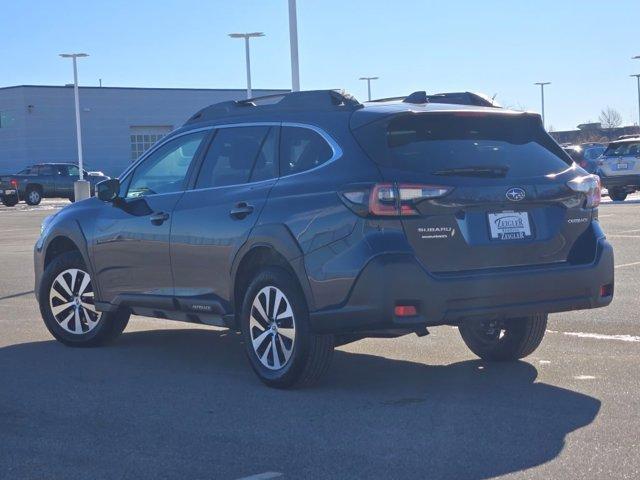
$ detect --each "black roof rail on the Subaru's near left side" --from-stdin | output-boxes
[185,90,362,125]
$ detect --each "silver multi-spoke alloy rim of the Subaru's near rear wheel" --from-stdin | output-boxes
[249,286,296,370]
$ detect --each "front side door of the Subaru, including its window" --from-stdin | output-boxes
[92,132,208,302]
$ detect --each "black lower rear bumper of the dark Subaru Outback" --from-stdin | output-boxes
[311,238,614,333]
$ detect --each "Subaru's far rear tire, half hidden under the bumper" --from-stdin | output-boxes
[458,315,547,362]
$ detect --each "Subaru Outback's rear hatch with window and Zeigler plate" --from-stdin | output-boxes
[354,111,592,273]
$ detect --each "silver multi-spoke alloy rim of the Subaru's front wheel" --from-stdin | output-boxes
[49,268,100,335]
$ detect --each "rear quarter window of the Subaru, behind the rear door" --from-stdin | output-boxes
[280,127,333,176]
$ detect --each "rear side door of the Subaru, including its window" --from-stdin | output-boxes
[171,124,279,312]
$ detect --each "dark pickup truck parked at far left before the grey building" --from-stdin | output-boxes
[0,163,109,207]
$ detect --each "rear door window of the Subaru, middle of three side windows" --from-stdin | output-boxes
[196,127,277,188]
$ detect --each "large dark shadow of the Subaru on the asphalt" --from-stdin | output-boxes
[0,329,600,480]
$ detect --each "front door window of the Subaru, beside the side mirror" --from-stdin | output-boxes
[126,132,207,198]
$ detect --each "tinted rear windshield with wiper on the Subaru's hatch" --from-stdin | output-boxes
[354,113,571,178]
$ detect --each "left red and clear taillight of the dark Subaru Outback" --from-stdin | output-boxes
[342,183,452,217]
